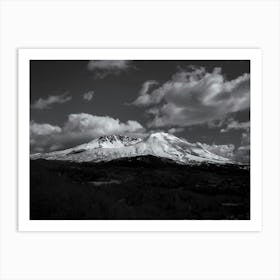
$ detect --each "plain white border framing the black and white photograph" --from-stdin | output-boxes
[18,49,262,231]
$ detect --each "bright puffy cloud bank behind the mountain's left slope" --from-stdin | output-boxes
[30,113,145,153]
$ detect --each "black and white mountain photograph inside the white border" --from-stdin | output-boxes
[30,60,250,220]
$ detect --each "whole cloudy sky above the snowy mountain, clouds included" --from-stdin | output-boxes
[30,60,250,162]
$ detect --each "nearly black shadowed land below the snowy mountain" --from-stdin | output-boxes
[30,156,250,220]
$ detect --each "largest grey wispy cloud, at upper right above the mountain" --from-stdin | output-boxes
[132,66,250,127]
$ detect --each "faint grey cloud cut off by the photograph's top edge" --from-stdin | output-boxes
[87,60,132,79]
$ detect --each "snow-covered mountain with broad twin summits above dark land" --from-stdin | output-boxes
[31,132,231,164]
